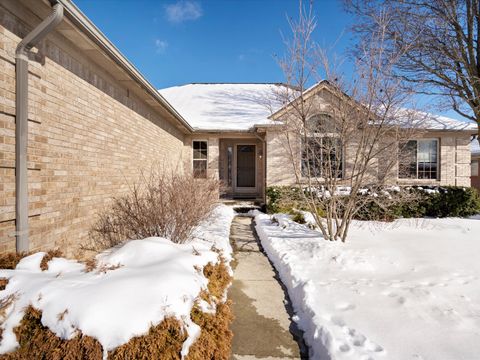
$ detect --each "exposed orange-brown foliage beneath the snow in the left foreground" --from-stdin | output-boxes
[0,260,233,360]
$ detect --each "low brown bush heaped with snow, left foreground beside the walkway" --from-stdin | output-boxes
[0,205,234,360]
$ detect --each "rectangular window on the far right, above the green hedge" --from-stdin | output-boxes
[398,139,438,179]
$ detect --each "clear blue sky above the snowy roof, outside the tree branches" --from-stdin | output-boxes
[74,0,460,118]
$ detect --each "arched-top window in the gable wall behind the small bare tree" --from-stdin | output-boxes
[301,114,343,178]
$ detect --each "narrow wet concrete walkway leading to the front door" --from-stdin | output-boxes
[229,216,307,360]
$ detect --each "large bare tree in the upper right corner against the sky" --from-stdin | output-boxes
[346,0,480,138]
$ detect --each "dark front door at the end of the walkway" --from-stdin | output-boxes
[235,144,257,192]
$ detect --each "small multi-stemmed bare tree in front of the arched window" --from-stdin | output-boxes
[272,3,422,241]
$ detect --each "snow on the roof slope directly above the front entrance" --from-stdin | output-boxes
[159,84,282,130]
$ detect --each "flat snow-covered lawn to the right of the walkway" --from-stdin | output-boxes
[256,213,480,360]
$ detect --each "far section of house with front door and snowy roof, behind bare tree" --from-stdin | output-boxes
[160,81,476,199]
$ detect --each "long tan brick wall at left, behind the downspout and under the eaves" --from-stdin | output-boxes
[0,5,185,253]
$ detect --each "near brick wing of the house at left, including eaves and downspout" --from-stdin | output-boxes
[0,0,193,253]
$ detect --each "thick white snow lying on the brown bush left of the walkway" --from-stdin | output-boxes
[0,205,234,355]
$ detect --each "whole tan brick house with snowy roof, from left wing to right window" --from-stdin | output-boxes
[0,0,473,253]
